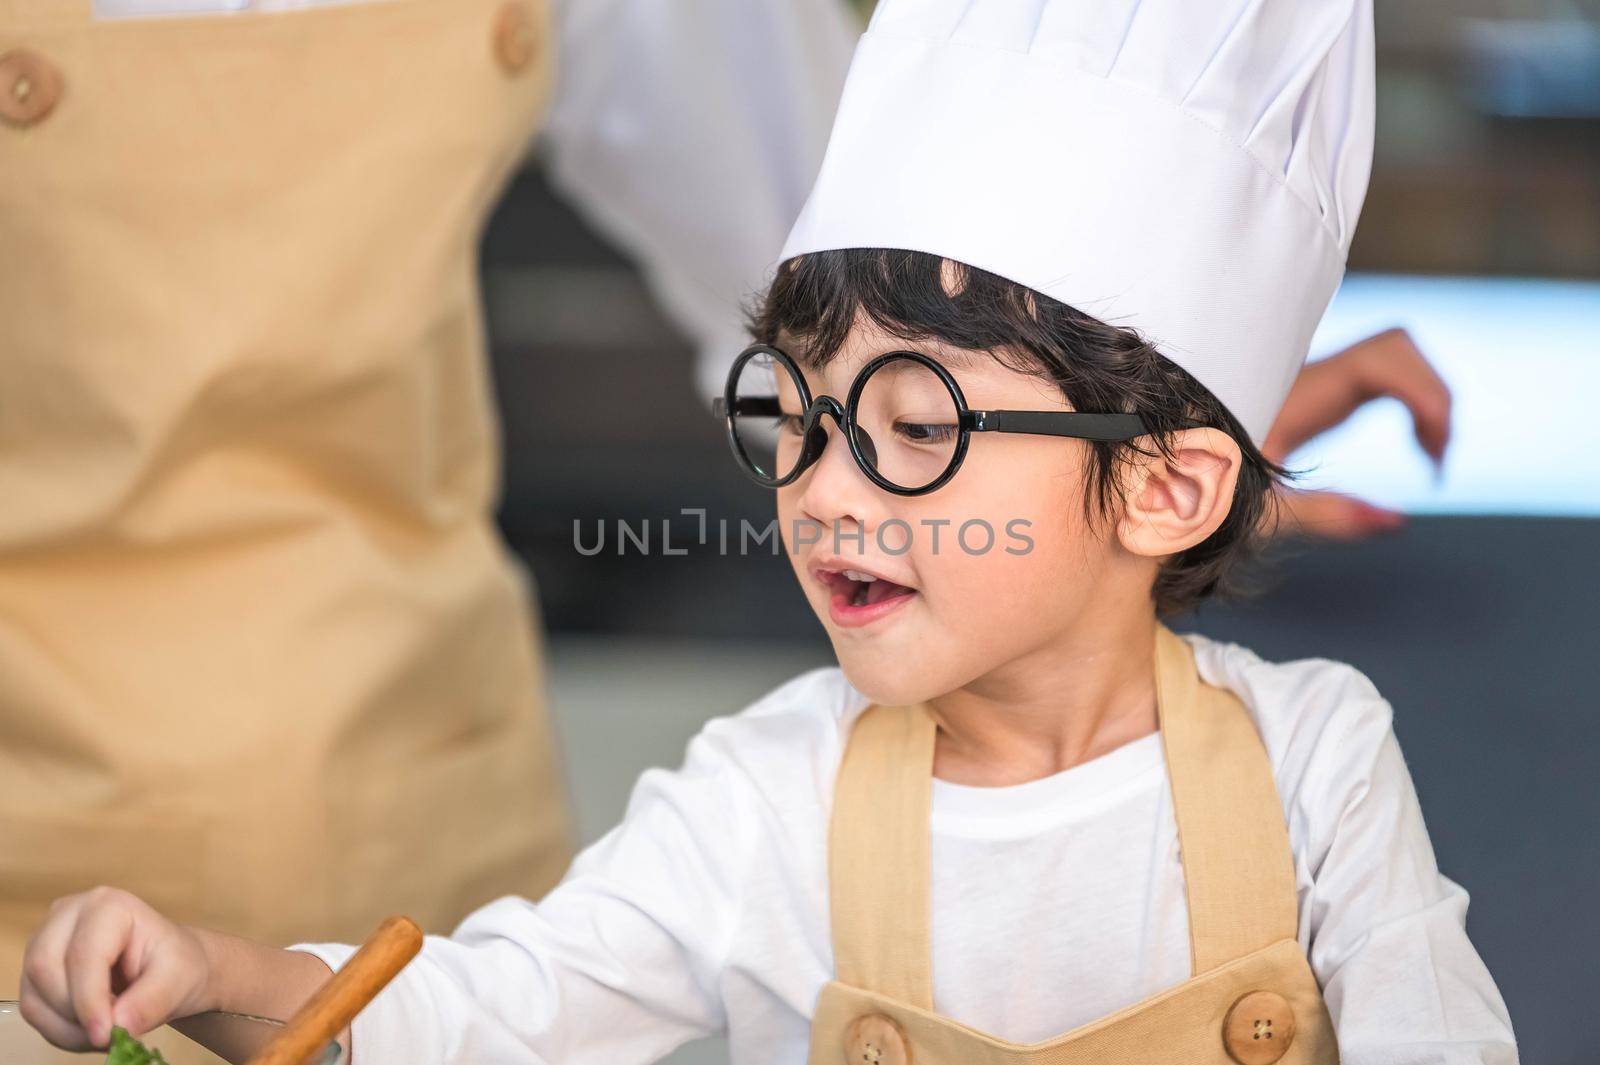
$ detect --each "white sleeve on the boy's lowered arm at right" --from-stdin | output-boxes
[1291,696,1517,1065]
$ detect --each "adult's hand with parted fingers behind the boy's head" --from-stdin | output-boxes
[1261,329,1450,540]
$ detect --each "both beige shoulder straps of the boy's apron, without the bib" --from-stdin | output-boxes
[829,622,1298,1011]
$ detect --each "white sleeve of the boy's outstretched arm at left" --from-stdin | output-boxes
[299,722,755,1065]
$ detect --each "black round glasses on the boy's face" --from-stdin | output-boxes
[712,344,1149,496]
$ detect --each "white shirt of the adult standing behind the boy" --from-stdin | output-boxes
[93,0,861,397]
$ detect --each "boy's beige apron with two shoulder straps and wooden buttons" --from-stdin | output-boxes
[810,625,1339,1065]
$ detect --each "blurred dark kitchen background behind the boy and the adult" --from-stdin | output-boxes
[483,0,1600,1065]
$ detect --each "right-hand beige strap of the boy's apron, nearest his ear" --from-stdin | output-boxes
[1155,625,1299,975]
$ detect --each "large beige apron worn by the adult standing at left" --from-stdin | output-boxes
[0,0,570,998]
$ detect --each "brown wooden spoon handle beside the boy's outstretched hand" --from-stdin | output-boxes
[248,916,422,1065]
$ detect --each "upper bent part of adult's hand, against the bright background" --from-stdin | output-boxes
[1262,329,1451,464]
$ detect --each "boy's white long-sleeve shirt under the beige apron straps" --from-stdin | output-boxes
[304,633,1517,1065]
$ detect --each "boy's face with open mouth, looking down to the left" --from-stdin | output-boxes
[778,323,1150,704]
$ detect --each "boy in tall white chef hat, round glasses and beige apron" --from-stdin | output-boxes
[18,0,1515,1065]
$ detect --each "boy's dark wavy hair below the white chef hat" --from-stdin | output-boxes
[749,248,1294,616]
